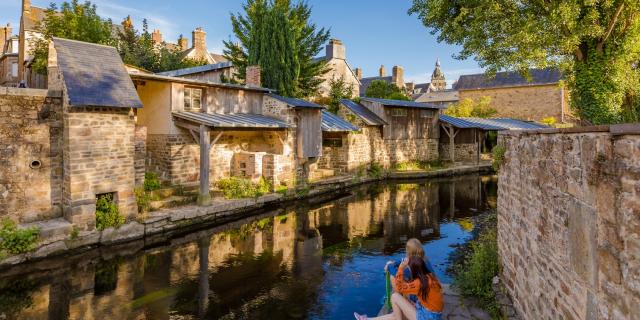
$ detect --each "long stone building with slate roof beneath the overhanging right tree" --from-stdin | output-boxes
[455,69,572,123]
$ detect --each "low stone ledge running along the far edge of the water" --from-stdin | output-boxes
[0,163,491,269]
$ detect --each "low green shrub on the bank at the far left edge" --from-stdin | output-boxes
[0,219,40,257]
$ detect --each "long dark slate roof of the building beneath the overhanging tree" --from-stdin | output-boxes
[455,68,562,90]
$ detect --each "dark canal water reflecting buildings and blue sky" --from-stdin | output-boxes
[0,175,497,320]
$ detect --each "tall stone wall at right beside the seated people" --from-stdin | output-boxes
[498,124,640,320]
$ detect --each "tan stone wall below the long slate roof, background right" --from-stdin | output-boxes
[459,84,569,122]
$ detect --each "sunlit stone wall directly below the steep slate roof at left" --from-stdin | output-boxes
[63,106,138,230]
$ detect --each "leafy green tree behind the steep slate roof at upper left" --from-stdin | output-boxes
[31,0,115,74]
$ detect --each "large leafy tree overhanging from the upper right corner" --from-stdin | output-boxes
[409,0,640,124]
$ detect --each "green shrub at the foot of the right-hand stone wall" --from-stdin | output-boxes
[453,226,501,319]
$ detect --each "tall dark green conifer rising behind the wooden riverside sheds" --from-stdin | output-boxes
[224,0,329,97]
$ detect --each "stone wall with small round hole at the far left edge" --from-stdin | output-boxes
[0,88,62,222]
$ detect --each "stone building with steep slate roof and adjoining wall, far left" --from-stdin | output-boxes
[0,38,144,231]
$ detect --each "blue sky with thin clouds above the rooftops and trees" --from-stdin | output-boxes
[0,0,482,84]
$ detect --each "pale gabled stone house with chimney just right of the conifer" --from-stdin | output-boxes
[316,39,362,97]
